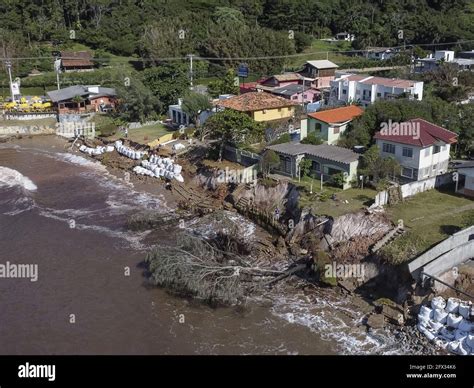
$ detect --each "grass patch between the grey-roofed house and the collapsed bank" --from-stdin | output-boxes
[293,177,377,217]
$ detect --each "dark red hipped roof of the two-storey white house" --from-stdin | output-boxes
[374,119,458,148]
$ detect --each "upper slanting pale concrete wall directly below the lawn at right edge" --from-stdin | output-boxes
[408,225,474,279]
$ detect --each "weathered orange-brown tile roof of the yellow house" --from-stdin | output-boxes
[216,92,298,112]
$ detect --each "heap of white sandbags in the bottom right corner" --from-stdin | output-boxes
[418,296,474,355]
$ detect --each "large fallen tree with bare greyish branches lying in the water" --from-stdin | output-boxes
[145,233,308,305]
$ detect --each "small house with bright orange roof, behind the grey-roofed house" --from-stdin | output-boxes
[302,105,364,144]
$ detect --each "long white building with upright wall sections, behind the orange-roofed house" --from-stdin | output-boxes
[329,74,423,107]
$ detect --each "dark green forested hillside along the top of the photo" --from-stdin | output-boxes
[0,0,474,73]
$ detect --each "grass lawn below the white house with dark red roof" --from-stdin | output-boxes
[386,189,474,252]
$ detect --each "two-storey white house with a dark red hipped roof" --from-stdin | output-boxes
[374,119,457,181]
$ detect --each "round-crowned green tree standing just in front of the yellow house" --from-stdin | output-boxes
[205,109,263,161]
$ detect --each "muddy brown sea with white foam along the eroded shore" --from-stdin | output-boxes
[0,136,414,354]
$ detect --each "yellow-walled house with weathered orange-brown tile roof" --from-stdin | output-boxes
[216,92,298,121]
